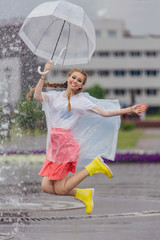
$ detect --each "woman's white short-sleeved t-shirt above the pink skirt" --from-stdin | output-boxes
[42,91,97,129]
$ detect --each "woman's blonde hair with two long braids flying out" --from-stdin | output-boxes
[26,68,87,112]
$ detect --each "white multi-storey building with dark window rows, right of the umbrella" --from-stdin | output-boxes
[92,20,160,107]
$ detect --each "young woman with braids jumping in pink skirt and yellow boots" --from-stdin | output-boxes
[34,62,147,214]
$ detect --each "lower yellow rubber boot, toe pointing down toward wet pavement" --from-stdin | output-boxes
[75,188,94,214]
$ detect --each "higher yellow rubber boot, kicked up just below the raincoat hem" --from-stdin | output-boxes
[85,157,113,178]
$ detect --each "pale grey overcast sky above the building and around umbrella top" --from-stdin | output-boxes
[0,0,160,35]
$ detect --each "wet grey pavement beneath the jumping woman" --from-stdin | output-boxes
[0,160,160,240]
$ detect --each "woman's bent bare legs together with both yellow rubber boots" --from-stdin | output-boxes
[42,157,113,214]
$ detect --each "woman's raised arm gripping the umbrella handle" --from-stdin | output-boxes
[34,62,52,102]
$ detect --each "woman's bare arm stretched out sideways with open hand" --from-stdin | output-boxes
[92,104,148,117]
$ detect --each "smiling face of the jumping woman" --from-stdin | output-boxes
[67,72,84,91]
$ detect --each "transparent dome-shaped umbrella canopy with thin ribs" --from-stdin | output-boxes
[19,1,96,65]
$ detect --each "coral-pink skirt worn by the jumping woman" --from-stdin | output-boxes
[39,128,80,180]
